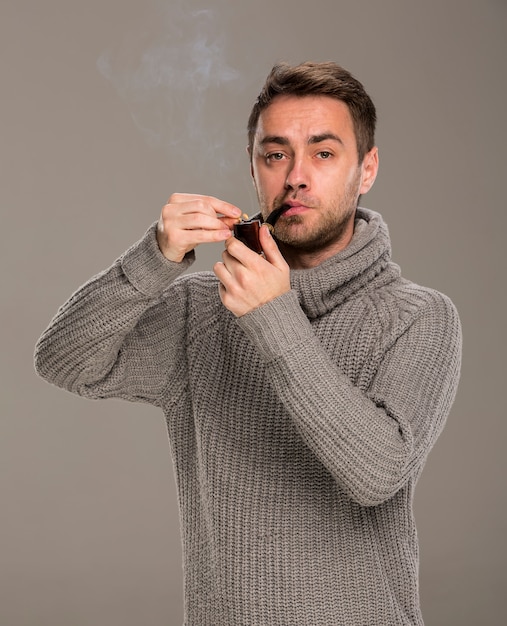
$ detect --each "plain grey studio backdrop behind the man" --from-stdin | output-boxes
[0,0,507,626]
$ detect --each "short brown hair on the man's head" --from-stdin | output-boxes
[248,61,377,163]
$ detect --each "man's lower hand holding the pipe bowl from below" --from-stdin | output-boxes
[213,226,291,317]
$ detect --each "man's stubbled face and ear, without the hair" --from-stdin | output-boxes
[251,96,378,262]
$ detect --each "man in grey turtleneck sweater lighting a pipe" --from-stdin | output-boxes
[36,63,461,626]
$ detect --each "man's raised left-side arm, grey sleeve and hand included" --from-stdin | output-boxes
[35,194,241,402]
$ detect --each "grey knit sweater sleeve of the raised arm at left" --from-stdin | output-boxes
[35,224,193,404]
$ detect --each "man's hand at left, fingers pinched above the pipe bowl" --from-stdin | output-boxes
[157,193,241,263]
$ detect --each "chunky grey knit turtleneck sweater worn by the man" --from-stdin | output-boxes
[36,209,461,626]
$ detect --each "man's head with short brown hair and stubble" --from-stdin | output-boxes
[248,63,378,268]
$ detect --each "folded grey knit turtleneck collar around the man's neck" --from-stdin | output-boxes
[291,208,400,319]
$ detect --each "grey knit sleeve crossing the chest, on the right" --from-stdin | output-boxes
[239,292,461,506]
